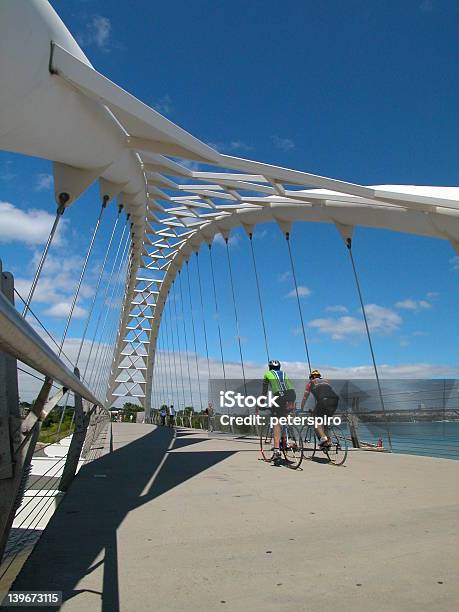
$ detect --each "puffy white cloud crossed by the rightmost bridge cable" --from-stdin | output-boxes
[309,304,402,340]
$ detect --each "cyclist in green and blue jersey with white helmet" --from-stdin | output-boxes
[262,359,296,465]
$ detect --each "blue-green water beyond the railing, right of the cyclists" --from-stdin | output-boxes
[358,421,459,459]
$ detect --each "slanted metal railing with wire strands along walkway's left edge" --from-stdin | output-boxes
[0,263,110,575]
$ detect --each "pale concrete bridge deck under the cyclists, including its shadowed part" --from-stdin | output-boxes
[9,424,459,612]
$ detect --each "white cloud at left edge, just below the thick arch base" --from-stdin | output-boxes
[0,202,65,245]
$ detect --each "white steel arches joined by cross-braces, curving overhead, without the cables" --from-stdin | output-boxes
[0,0,459,407]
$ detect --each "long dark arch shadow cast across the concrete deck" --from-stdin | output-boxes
[12,426,235,612]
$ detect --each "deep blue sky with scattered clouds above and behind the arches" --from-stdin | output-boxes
[0,0,459,394]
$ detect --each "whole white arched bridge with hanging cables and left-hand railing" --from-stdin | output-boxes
[0,0,459,609]
